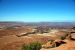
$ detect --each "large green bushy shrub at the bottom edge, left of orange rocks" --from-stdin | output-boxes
[22,42,42,50]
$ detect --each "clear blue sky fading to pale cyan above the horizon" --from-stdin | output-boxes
[0,0,75,22]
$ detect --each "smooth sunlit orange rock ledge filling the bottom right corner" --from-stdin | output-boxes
[41,40,75,50]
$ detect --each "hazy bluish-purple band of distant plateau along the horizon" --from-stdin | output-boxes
[0,22,75,28]
